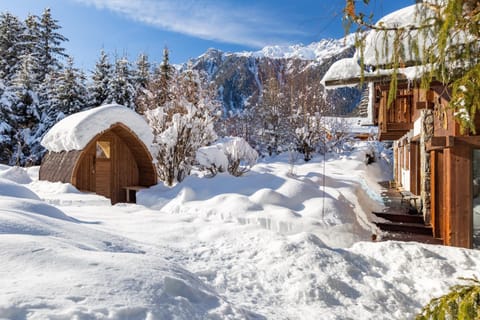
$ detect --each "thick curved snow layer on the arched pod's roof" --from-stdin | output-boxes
[41,104,153,152]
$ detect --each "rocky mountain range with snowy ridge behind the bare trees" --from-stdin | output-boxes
[188,35,361,115]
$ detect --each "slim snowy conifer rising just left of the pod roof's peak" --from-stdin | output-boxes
[88,49,113,107]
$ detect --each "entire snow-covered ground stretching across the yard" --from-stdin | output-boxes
[0,145,480,319]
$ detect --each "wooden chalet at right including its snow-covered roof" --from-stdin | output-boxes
[322,2,480,248]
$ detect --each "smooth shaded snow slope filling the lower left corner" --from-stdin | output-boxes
[0,188,248,319]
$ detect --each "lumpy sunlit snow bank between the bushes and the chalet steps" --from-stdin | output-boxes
[141,142,379,247]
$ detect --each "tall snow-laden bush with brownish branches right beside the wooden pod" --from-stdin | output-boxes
[140,53,218,186]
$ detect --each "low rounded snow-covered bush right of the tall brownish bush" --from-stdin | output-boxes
[196,137,258,177]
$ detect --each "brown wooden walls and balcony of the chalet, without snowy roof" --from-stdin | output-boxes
[326,72,480,248]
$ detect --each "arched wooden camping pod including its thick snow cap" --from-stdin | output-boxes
[40,104,157,203]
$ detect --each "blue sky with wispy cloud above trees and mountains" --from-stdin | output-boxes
[0,0,414,70]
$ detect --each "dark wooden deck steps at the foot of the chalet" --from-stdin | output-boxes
[372,181,443,244]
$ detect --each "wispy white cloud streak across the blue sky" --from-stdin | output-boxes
[75,0,305,47]
